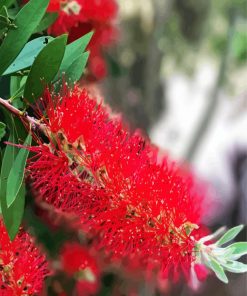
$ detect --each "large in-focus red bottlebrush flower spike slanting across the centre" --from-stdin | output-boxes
[27,86,208,279]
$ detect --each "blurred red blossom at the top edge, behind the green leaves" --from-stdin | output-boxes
[42,0,118,79]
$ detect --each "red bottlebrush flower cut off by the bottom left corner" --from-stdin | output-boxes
[0,220,48,296]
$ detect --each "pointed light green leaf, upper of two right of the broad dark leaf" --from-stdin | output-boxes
[54,32,93,80]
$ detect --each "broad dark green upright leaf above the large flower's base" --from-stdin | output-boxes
[24,35,67,103]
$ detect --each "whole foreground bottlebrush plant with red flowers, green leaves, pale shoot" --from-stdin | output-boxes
[0,0,247,296]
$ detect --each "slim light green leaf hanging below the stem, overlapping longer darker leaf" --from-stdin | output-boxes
[6,135,32,207]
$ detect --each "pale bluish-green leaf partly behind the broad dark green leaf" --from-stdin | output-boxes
[3,36,53,75]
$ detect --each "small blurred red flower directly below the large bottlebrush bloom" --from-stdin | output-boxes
[60,243,99,295]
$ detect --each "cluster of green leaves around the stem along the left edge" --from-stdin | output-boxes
[0,0,93,240]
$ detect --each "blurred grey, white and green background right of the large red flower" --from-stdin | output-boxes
[99,0,247,296]
